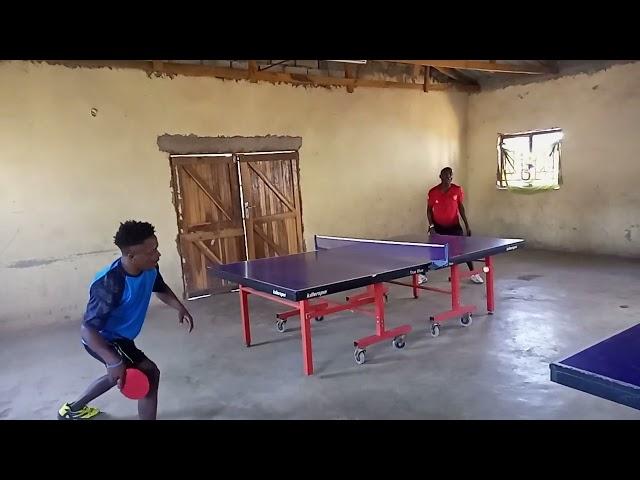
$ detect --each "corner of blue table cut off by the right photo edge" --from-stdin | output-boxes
[549,324,640,410]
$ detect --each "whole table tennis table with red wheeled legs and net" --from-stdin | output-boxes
[214,234,524,375]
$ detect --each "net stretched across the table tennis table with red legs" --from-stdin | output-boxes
[315,235,449,266]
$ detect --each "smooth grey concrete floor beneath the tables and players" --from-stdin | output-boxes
[0,249,640,419]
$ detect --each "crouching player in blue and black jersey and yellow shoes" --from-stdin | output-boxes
[58,220,193,420]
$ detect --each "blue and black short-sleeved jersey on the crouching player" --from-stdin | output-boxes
[84,258,168,341]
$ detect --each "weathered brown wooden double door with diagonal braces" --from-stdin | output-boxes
[171,152,304,298]
